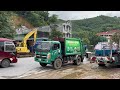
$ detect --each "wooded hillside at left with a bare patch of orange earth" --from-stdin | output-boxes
[0,11,58,38]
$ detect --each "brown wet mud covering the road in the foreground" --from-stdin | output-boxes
[18,63,120,79]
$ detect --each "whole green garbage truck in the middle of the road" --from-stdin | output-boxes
[35,38,85,69]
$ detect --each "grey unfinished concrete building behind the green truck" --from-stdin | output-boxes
[38,21,72,38]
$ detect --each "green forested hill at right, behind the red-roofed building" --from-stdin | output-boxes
[72,15,120,45]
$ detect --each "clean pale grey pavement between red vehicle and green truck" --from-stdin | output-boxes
[0,57,40,77]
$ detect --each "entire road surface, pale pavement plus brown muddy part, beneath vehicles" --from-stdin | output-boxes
[0,57,120,79]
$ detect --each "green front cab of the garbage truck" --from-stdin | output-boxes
[35,41,62,66]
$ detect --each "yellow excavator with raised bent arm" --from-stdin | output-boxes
[16,29,37,54]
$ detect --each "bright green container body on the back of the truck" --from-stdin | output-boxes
[54,38,84,56]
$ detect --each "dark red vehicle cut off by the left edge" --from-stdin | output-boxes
[0,38,17,68]
